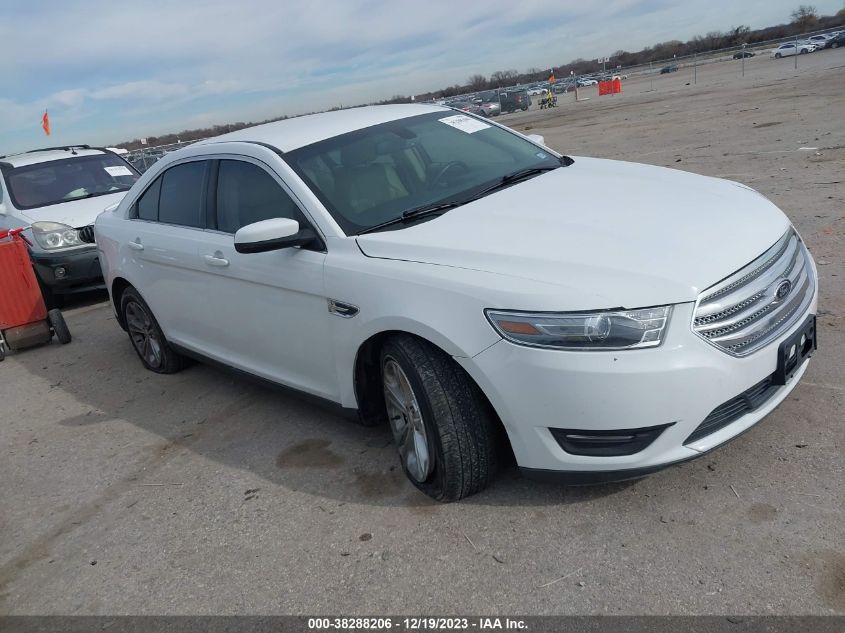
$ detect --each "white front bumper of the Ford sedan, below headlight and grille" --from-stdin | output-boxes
[456,296,817,483]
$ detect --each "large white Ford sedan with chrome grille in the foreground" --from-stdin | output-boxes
[96,105,817,500]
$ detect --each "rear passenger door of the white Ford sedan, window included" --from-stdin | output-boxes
[125,159,211,347]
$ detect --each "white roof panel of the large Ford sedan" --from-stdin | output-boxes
[195,104,450,152]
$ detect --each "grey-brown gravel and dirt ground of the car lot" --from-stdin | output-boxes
[0,49,845,614]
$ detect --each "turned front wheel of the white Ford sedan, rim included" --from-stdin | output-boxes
[381,335,496,501]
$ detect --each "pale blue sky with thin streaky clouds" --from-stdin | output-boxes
[0,0,843,154]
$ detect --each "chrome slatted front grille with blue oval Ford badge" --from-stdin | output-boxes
[693,229,816,356]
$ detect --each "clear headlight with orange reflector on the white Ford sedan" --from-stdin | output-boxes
[485,306,672,350]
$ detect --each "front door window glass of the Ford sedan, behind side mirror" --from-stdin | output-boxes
[217,160,304,233]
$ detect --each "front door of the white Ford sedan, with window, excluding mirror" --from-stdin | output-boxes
[193,157,338,400]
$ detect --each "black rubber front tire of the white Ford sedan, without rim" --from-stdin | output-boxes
[379,334,498,501]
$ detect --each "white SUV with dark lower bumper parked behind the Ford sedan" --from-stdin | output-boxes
[0,145,140,307]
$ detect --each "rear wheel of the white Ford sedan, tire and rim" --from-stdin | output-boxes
[120,287,185,374]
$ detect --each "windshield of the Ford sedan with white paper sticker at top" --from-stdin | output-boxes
[285,111,561,235]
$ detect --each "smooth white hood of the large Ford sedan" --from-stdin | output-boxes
[357,158,790,310]
